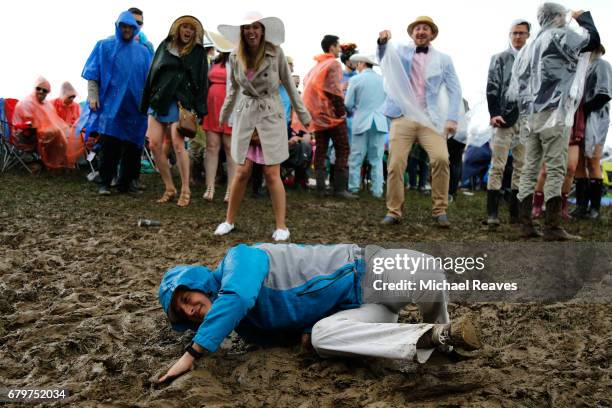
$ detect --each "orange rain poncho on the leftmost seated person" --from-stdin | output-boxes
[13,78,85,169]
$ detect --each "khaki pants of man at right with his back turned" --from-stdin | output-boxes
[517,111,570,201]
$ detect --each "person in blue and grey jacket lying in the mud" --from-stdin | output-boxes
[158,244,481,382]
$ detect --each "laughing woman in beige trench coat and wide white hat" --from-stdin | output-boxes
[215,13,310,241]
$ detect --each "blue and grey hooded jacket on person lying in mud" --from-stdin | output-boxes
[159,244,365,352]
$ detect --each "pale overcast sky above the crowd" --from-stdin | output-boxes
[0,0,612,143]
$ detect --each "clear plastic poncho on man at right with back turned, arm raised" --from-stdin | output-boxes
[508,3,590,132]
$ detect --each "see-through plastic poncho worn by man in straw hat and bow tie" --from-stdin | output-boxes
[380,41,465,134]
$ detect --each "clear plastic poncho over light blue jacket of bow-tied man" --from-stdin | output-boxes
[380,41,466,135]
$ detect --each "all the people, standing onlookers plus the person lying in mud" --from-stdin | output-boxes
[3,3,612,388]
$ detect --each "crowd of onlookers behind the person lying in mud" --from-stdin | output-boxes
[7,3,612,241]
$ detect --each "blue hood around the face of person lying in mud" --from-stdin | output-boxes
[158,265,221,331]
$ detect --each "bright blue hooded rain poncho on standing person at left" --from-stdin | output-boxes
[81,11,152,146]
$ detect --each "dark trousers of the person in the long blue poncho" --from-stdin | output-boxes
[100,135,142,191]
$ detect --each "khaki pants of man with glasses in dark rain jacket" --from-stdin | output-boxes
[487,123,525,190]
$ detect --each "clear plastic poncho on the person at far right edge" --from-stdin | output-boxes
[584,58,612,157]
